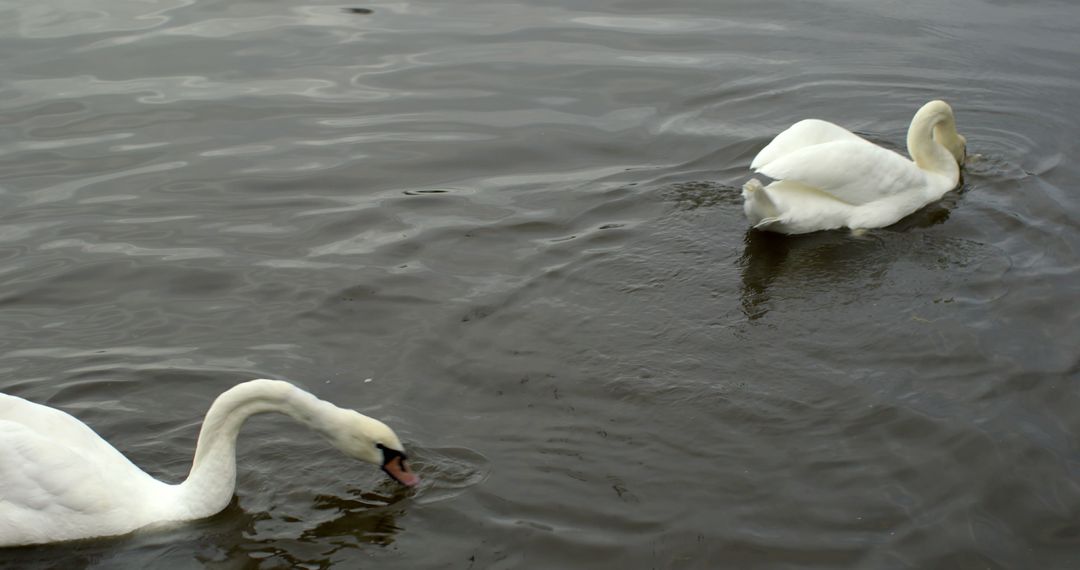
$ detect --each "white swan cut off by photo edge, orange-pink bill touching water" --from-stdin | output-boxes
[0,380,419,546]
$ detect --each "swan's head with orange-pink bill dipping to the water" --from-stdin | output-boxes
[330,410,420,487]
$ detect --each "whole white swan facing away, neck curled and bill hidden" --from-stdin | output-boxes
[742,100,967,233]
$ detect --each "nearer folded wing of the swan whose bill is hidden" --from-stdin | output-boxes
[757,137,927,205]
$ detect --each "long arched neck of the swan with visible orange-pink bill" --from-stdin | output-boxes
[177,380,340,517]
